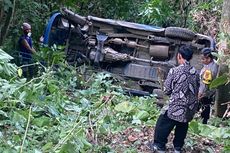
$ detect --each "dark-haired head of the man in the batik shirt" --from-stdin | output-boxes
[177,45,193,64]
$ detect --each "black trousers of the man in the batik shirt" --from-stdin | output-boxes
[154,112,188,151]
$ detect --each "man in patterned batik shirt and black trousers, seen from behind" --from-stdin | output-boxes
[151,46,199,153]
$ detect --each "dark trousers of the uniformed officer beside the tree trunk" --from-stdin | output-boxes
[199,97,213,124]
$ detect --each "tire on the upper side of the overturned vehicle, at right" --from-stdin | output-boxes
[165,27,196,41]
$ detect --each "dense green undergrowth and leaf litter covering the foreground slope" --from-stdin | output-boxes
[0,49,230,153]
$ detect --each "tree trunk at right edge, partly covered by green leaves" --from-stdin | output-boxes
[215,0,230,117]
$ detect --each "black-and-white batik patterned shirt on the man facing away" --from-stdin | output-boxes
[164,61,199,122]
